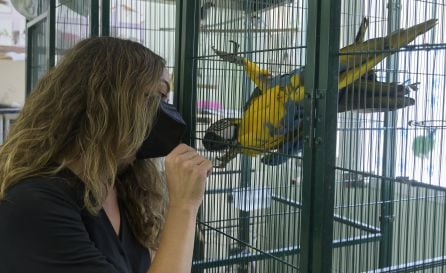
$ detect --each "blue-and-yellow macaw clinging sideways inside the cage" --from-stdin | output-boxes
[202,18,437,167]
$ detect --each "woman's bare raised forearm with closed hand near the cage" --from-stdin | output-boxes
[149,144,212,273]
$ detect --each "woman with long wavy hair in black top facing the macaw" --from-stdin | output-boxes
[0,37,212,273]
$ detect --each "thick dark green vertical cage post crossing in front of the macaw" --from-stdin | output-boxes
[300,0,340,273]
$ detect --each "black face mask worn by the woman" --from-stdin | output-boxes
[136,101,186,159]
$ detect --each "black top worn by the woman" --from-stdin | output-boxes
[0,170,150,273]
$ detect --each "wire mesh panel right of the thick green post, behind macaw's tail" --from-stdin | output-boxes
[333,0,446,272]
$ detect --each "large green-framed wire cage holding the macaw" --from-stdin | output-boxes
[23,0,446,273]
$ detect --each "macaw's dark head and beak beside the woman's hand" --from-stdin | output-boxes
[202,118,240,151]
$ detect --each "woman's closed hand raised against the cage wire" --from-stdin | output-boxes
[165,144,212,211]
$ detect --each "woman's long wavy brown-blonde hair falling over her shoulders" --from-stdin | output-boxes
[0,37,167,249]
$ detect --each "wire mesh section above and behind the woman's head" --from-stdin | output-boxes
[28,0,176,92]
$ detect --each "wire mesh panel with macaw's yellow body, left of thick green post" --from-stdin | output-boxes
[191,0,307,272]
